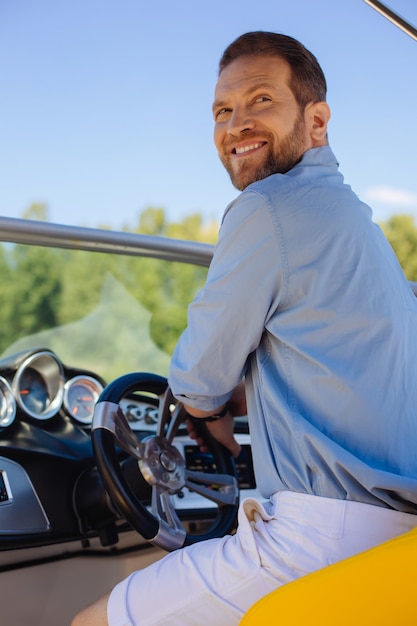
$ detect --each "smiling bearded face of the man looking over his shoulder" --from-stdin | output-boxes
[213,56,312,191]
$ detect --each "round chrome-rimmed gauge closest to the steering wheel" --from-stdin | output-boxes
[64,376,103,425]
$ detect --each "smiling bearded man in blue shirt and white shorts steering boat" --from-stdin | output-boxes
[74,32,417,626]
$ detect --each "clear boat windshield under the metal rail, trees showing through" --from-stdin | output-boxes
[0,243,207,382]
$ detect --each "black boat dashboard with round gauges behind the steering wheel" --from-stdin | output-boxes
[0,349,259,571]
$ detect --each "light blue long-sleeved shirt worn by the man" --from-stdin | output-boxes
[169,146,417,513]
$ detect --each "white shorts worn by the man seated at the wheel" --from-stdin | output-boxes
[107,491,417,626]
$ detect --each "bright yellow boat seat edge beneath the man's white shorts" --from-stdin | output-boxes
[239,528,417,626]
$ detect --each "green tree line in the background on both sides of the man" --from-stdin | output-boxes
[0,205,417,354]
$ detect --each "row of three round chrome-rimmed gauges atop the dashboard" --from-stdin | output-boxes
[0,350,105,428]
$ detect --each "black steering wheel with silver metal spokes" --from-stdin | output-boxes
[91,372,239,551]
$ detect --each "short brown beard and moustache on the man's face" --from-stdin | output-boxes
[220,114,305,191]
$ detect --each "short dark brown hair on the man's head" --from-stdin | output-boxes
[219,31,327,111]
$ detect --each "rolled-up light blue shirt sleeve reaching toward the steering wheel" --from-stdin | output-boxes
[169,191,283,411]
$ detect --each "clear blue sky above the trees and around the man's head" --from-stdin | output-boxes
[0,0,417,229]
